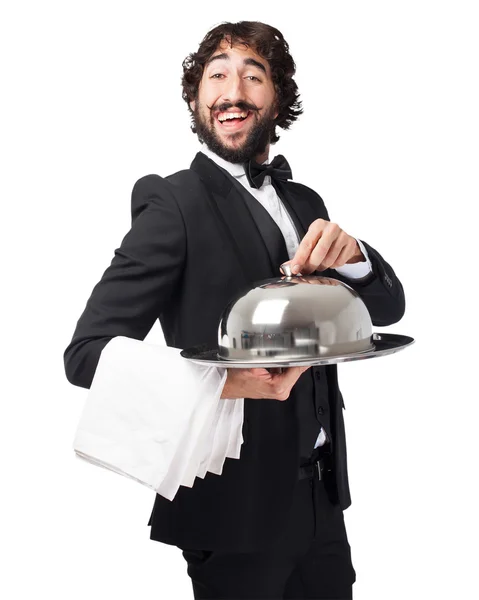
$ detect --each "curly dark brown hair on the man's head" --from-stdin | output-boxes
[181,21,303,144]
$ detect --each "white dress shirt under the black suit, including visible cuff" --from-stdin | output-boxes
[201,144,372,448]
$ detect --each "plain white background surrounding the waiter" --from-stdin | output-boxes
[0,0,479,600]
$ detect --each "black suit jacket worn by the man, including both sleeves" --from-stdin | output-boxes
[64,152,405,551]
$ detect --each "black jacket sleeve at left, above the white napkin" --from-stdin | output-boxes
[63,175,186,388]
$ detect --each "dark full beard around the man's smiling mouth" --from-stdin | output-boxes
[193,99,275,163]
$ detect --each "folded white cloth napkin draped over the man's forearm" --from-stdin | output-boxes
[73,336,244,500]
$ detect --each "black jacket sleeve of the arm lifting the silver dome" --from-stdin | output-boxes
[315,192,406,327]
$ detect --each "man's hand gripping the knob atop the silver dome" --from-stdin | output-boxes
[289,219,366,275]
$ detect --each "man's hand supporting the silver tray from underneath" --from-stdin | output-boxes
[221,367,309,401]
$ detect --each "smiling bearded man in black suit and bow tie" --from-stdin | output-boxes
[64,22,405,599]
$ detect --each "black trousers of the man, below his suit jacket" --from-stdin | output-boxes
[180,449,356,600]
